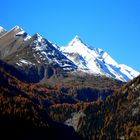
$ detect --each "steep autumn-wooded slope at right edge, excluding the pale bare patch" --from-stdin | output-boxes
[78,76,140,140]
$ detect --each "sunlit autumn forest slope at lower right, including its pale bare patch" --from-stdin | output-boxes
[48,76,140,140]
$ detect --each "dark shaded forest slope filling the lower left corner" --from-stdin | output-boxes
[0,62,81,140]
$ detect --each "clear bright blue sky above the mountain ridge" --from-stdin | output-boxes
[0,0,140,72]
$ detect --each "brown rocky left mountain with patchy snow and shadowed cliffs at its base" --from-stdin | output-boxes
[0,26,77,83]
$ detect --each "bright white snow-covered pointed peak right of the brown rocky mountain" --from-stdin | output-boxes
[60,36,139,82]
